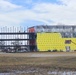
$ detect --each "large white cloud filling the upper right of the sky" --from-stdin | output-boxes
[31,0,76,25]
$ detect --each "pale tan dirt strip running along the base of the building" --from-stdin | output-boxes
[0,52,76,57]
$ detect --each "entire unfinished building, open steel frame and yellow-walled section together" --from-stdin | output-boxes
[0,25,76,52]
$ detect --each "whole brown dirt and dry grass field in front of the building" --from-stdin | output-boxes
[0,52,76,75]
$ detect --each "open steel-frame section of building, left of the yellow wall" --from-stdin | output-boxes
[0,27,35,52]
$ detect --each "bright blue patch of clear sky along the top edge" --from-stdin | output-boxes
[10,0,61,9]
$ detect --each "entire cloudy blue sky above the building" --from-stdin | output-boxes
[0,0,76,27]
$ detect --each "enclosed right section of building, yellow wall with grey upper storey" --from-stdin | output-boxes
[28,25,76,51]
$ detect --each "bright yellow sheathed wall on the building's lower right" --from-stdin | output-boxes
[36,33,76,51]
